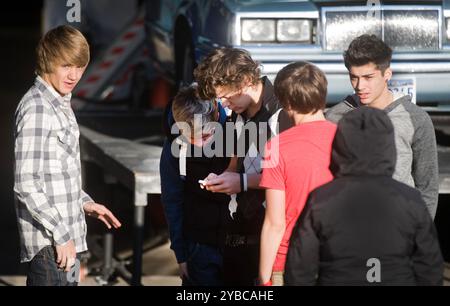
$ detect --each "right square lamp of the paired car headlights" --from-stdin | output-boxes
[277,19,312,42]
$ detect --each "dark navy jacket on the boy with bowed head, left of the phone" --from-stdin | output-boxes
[160,103,229,263]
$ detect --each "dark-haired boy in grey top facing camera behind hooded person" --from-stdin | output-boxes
[325,35,439,218]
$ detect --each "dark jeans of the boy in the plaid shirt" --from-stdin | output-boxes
[27,246,79,286]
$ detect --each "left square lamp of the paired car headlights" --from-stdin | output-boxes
[241,19,275,42]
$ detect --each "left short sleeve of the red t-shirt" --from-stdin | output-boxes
[259,136,286,190]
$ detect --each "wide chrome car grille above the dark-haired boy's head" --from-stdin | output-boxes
[322,6,441,51]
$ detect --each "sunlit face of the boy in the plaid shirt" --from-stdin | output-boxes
[43,64,86,96]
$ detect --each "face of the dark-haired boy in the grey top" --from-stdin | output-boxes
[349,63,392,105]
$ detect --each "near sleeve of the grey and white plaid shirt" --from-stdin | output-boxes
[14,103,70,244]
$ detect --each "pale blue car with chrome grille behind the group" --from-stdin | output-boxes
[145,0,450,106]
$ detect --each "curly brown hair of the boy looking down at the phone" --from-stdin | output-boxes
[194,47,261,99]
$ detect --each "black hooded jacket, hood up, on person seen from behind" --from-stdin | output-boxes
[285,107,443,285]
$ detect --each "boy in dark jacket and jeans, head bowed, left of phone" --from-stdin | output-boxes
[160,85,229,286]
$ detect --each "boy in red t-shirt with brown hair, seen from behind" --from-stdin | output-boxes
[259,62,336,285]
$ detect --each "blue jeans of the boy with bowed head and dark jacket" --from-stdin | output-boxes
[183,242,223,286]
